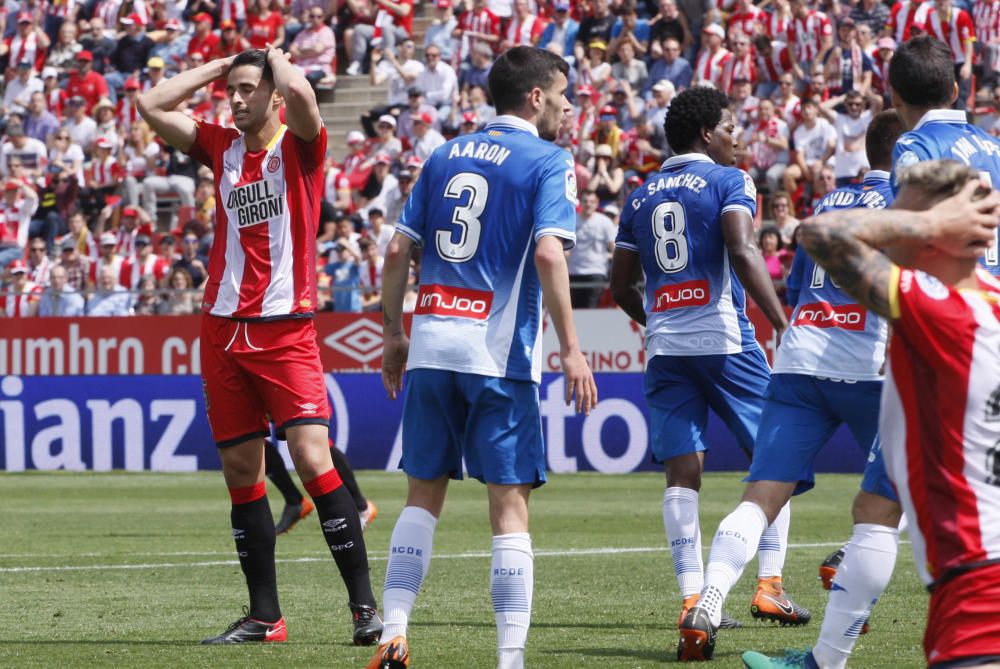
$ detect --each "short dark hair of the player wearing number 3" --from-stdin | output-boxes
[489,46,569,114]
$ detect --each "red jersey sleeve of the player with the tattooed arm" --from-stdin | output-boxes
[889,265,975,353]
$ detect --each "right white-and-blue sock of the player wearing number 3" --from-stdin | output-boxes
[490,532,535,669]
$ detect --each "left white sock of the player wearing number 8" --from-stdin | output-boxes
[663,487,705,597]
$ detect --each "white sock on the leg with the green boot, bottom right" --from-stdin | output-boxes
[813,523,899,669]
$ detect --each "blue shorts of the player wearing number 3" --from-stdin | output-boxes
[399,369,545,487]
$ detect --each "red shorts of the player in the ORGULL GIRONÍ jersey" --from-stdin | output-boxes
[201,314,330,448]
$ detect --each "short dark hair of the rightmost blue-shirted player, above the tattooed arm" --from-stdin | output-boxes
[889,36,955,108]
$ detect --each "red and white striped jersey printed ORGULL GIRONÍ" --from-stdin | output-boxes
[190,122,326,318]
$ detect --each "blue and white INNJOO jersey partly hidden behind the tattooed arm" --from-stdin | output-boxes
[773,170,894,381]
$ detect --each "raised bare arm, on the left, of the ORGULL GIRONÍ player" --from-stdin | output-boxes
[136,56,234,152]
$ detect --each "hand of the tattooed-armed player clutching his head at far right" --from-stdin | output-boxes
[928,180,1000,258]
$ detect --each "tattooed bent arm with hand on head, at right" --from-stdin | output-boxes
[799,181,1000,318]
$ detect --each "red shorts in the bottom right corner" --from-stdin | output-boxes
[924,564,1000,667]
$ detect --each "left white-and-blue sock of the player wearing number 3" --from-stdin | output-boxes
[379,506,437,644]
